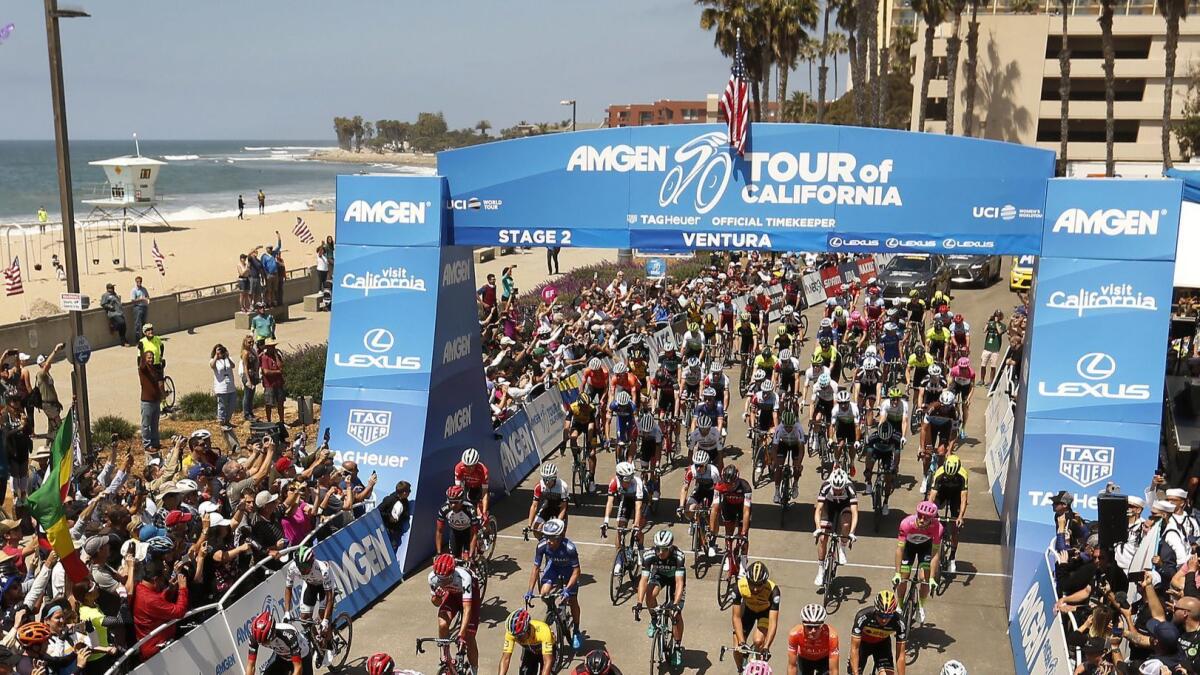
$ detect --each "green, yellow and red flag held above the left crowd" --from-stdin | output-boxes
[29,410,88,583]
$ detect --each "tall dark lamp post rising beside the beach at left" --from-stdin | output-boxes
[46,0,91,452]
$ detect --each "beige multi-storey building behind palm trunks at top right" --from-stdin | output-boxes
[895,0,1200,161]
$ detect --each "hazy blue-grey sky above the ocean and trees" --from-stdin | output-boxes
[0,0,820,141]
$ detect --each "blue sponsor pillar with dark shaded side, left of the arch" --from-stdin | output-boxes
[320,175,499,573]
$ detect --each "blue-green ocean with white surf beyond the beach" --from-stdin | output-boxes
[0,139,433,225]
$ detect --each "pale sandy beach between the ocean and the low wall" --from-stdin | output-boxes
[0,210,334,323]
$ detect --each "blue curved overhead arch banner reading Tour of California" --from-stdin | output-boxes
[438,124,1054,253]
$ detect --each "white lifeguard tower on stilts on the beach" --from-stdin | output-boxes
[82,142,170,268]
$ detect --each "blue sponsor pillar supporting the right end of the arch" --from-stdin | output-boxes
[1002,179,1182,673]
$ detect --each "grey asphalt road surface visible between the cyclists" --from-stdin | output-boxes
[338,259,1016,675]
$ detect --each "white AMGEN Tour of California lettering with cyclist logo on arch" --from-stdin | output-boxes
[566,131,904,214]
